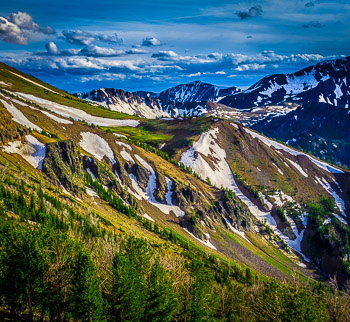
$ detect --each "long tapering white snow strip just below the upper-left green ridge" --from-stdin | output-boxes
[16,92,139,127]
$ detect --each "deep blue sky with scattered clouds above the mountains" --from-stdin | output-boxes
[0,0,350,93]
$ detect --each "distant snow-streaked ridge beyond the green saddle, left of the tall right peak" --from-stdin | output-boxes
[74,81,240,118]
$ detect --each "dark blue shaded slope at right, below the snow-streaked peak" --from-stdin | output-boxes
[252,103,350,167]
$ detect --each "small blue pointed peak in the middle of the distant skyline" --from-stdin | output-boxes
[157,81,241,103]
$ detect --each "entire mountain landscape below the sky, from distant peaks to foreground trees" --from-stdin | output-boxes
[0,57,350,321]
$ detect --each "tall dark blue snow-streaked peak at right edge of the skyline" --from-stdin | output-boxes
[219,57,350,108]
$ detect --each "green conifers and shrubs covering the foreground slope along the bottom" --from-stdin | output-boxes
[0,162,350,321]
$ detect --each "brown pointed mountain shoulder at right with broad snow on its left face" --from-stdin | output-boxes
[180,122,350,282]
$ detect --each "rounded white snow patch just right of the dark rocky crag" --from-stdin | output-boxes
[79,132,115,164]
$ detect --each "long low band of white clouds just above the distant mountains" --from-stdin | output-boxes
[4,49,336,92]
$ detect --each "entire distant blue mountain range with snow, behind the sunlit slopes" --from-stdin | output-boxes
[75,57,350,166]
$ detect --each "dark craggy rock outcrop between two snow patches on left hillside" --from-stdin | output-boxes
[42,141,84,193]
